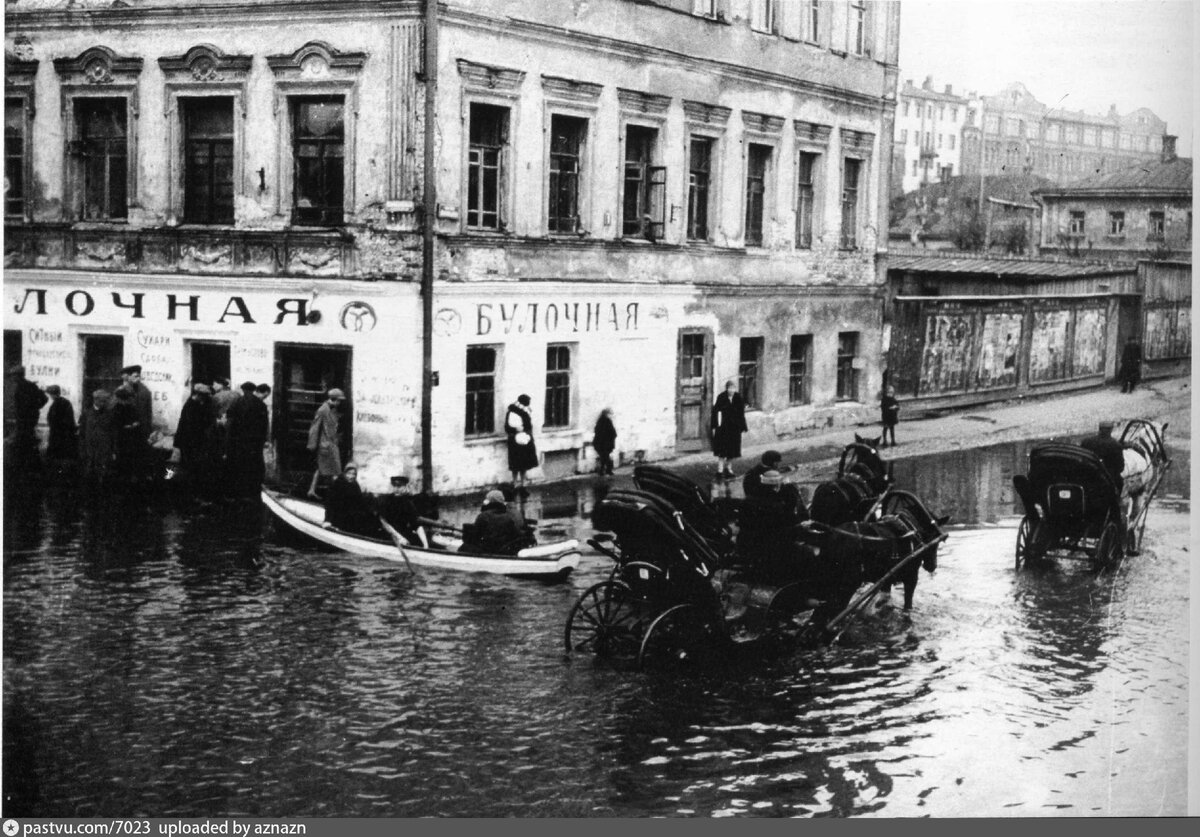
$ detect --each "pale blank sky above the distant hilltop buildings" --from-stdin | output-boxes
[900,0,1200,157]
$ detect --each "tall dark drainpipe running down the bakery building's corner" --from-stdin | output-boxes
[421,0,438,493]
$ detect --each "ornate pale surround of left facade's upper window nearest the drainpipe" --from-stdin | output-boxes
[266,41,367,229]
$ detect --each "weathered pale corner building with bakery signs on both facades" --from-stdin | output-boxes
[5,0,899,492]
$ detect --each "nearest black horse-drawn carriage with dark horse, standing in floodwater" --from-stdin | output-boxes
[565,441,946,668]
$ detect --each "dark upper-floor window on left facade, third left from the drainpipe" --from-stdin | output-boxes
[71,97,128,221]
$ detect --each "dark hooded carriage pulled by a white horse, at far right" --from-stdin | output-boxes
[1013,419,1171,570]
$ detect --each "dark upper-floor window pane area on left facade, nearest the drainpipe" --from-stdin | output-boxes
[292,96,346,227]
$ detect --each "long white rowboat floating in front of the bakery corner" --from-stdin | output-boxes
[263,488,580,580]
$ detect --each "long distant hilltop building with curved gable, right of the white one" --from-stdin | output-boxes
[960,82,1166,185]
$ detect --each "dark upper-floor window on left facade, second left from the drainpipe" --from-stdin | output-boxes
[181,97,233,224]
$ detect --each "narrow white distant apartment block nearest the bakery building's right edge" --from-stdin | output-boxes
[893,76,971,192]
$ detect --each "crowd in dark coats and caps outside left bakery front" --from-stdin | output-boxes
[6,363,271,499]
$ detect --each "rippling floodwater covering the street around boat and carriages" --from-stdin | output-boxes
[2,445,1189,817]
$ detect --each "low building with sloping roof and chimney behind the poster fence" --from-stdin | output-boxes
[1033,136,1192,260]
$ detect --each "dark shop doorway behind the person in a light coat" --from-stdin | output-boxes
[272,343,354,474]
